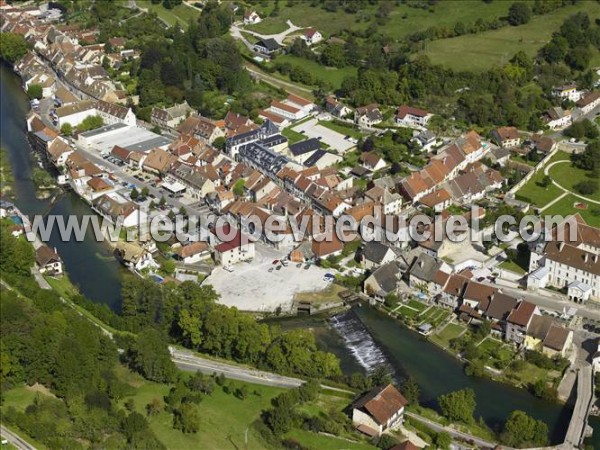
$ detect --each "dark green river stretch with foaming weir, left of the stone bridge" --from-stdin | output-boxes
[276,306,576,448]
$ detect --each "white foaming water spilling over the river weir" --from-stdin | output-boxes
[331,311,393,375]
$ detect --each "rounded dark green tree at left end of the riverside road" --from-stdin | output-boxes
[129,328,177,383]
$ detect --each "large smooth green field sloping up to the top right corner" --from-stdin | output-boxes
[424,1,600,70]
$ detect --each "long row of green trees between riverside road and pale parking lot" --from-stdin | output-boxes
[122,278,340,378]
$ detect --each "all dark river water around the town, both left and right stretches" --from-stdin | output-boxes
[0,64,600,449]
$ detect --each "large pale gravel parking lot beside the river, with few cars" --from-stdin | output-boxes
[205,247,329,312]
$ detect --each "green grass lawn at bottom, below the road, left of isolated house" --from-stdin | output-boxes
[123,374,285,450]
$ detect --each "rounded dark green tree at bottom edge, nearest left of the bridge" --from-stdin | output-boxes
[500,411,548,448]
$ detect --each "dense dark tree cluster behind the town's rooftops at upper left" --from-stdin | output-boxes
[132,2,250,115]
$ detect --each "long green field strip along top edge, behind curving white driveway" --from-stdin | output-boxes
[248,0,510,39]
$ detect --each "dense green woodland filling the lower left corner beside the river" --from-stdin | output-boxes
[0,222,163,449]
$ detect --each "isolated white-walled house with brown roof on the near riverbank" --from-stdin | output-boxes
[352,384,408,436]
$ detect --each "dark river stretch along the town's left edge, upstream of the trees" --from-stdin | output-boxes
[0,64,125,310]
